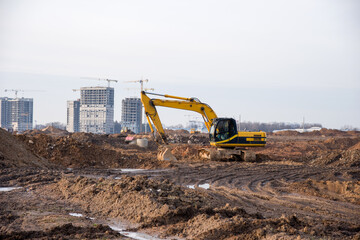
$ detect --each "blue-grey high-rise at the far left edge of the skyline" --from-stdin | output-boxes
[0,98,33,132]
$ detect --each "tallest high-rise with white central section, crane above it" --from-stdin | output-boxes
[80,87,114,133]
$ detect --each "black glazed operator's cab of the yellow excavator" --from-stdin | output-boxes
[210,118,237,142]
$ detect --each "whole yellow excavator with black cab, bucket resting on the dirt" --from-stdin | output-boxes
[141,91,266,161]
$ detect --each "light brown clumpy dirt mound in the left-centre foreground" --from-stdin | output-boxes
[52,176,217,226]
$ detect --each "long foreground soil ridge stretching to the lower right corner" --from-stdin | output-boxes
[44,176,357,239]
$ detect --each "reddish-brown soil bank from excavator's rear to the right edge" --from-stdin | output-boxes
[254,133,360,167]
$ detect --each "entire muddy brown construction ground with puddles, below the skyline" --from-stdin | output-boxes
[0,127,360,240]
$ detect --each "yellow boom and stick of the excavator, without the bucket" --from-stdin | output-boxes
[141,91,217,143]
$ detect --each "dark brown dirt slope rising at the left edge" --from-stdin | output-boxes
[0,128,50,168]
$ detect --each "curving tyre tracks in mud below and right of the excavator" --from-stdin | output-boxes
[157,163,360,224]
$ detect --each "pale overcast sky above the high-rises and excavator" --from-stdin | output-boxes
[0,0,360,128]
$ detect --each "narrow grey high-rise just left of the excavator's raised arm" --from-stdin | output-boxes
[121,98,142,133]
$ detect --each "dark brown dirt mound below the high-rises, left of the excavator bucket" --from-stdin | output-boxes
[18,133,168,168]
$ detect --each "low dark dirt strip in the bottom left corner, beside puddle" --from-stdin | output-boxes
[0,223,121,239]
